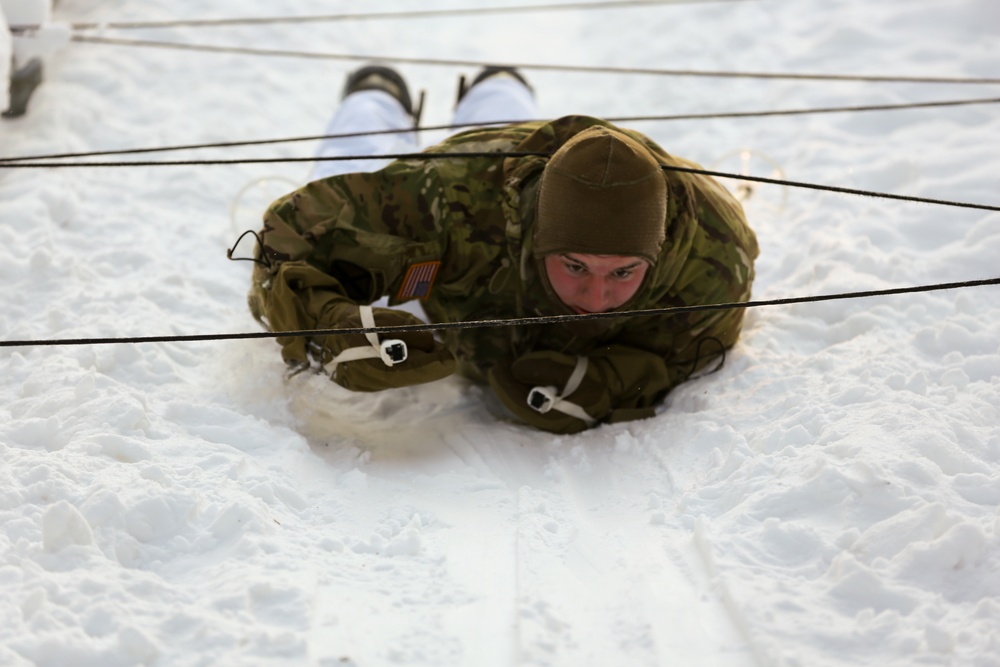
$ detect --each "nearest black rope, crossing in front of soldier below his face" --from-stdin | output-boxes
[0,278,1000,347]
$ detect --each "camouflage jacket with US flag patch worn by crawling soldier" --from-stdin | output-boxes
[250,116,758,418]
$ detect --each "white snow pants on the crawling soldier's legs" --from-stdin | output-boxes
[310,76,539,180]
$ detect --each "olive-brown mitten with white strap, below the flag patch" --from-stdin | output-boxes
[313,301,456,391]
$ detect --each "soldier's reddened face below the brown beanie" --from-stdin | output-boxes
[544,253,649,313]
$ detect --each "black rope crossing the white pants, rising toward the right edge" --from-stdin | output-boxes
[0,97,1000,166]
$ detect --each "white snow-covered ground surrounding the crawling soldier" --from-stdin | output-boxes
[0,0,1000,667]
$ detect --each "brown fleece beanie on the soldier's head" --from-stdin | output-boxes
[534,125,667,263]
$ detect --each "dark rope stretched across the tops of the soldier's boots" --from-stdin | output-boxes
[72,35,1000,84]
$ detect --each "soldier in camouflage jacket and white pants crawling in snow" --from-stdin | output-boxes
[249,65,758,433]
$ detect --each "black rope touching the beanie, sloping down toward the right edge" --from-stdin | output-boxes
[0,151,1000,211]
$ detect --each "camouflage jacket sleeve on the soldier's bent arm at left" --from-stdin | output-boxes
[249,161,448,364]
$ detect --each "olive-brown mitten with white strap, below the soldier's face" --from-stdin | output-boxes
[489,351,611,433]
